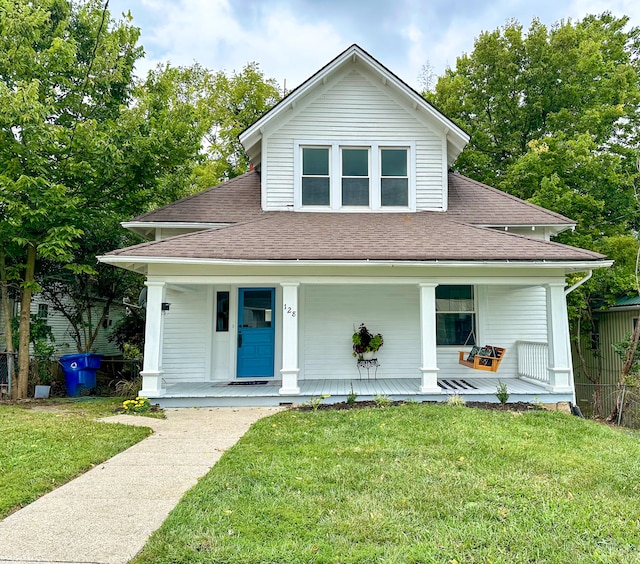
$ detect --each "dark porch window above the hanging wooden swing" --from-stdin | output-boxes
[436,285,476,345]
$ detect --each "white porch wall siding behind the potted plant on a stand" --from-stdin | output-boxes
[301,286,420,380]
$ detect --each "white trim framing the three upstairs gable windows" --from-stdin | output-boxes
[293,139,416,213]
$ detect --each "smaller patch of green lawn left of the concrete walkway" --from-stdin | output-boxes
[0,398,150,519]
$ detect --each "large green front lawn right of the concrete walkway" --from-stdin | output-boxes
[134,405,640,564]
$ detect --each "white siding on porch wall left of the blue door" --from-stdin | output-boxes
[162,286,213,383]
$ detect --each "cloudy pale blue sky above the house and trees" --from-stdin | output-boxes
[109,0,640,91]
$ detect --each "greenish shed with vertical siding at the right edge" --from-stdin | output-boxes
[573,296,640,415]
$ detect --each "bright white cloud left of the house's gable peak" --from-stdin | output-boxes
[134,0,349,90]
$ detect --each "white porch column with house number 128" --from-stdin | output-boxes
[279,282,300,395]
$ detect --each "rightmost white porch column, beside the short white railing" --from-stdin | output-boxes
[545,281,573,392]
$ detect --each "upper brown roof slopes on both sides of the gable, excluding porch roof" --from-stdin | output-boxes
[131,172,575,226]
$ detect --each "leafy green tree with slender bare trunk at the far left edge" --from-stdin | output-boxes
[0,0,141,397]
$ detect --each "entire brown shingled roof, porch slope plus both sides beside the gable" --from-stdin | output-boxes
[112,172,605,261]
